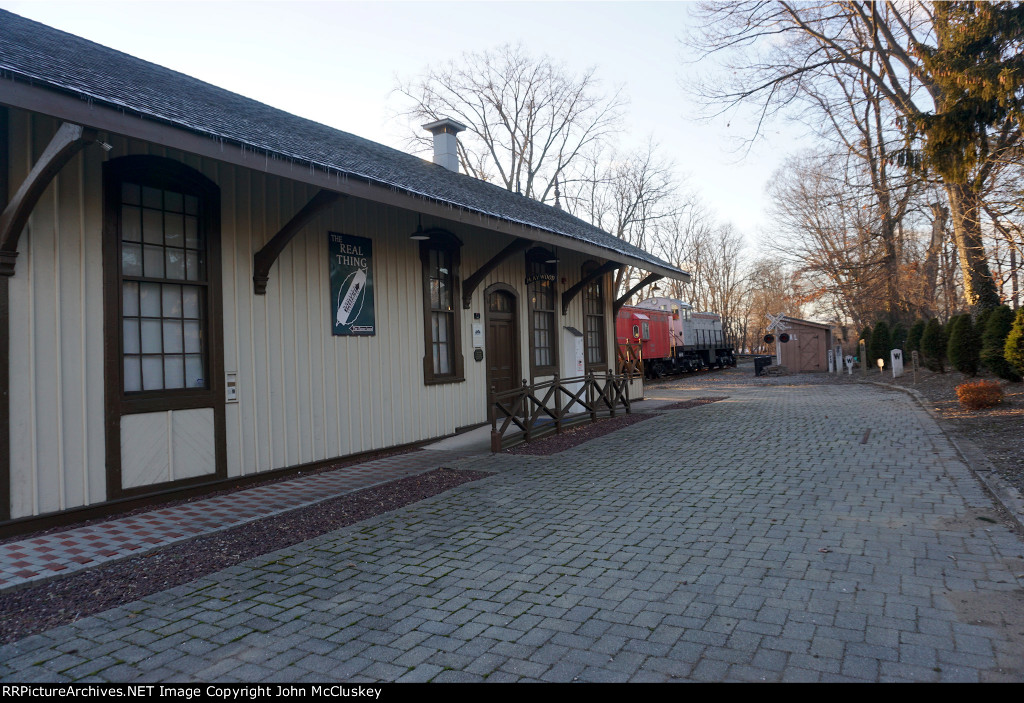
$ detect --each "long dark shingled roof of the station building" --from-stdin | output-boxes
[0,10,689,280]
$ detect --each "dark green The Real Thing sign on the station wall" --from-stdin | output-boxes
[327,232,376,336]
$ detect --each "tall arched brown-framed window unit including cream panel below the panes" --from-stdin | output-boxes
[103,157,226,499]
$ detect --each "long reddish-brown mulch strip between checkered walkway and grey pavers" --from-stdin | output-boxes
[0,469,490,643]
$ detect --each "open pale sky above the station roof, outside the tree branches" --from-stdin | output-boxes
[0,0,801,241]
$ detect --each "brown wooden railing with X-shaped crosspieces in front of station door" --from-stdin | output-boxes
[487,369,631,451]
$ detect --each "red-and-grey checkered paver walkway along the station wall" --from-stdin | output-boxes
[0,450,465,590]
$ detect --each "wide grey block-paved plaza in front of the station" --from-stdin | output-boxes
[0,378,1024,683]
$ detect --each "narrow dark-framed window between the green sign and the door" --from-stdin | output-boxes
[420,229,464,384]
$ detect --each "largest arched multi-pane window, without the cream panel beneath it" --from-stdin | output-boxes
[104,157,220,401]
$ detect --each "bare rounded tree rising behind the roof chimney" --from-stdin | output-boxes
[397,44,625,202]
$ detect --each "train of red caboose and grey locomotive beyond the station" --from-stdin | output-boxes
[615,298,736,379]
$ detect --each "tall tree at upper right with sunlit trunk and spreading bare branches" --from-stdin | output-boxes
[694,1,1021,307]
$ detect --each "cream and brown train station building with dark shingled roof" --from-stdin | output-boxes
[0,11,688,531]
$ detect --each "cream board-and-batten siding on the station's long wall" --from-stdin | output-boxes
[9,109,614,518]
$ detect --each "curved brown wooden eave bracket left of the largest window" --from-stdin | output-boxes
[0,122,96,276]
